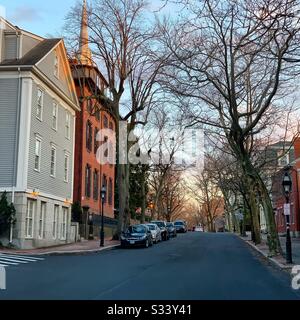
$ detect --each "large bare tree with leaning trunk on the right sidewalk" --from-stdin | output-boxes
[160,0,299,254]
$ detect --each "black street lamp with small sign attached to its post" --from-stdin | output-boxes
[282,168,293,263]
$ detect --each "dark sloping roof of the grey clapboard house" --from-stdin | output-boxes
[0,39,62,67]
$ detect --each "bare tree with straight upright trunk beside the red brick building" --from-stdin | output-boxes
[67,0,164,234]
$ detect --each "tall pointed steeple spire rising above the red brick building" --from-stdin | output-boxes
[79,0,92,65]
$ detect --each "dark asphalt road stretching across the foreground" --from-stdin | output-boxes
[0,232,300,300]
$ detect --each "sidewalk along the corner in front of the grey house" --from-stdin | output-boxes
[0,239,119,255]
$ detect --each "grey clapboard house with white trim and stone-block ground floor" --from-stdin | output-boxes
[0,17,80,249]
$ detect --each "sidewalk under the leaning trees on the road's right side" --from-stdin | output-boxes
[240,232,300,269]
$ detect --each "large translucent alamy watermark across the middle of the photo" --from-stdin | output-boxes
[96,121,204,168]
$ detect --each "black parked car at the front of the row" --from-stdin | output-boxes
[121,224,153,248]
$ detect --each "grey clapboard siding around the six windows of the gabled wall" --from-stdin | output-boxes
[28,84,74,199]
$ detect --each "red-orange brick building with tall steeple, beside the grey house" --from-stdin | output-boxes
[70,1,117,238]
